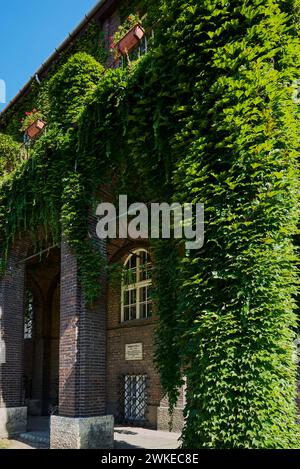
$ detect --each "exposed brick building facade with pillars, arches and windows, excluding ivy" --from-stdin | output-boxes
[0,0,298,448]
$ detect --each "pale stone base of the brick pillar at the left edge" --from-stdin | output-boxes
[0,407,27,438]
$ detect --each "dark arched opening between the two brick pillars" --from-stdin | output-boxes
[24,249,60,416]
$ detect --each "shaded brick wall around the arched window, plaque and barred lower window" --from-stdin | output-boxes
[107,240,183,430]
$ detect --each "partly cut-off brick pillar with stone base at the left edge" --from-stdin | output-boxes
[0,248,27,438]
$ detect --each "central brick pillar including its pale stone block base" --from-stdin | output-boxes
[51,221,113,448]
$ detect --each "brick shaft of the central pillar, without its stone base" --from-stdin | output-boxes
[59,217,106,417]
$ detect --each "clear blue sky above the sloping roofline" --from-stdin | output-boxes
[0,0,98,111]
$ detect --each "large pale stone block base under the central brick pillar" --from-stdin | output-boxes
[50,415,114,449]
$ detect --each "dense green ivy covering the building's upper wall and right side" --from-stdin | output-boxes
[0,0,300,448]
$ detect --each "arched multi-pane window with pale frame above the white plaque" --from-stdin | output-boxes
[121,249,152,322]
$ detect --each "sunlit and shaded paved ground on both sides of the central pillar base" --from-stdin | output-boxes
[0,417,180,449]
